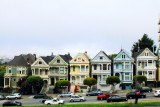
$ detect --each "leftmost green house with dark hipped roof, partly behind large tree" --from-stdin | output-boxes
[4,54,36,89]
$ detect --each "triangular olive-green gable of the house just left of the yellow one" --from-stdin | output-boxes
[49,55,68,65]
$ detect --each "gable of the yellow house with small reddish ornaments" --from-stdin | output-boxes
[70,53,89,63]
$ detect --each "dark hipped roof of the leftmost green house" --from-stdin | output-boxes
[7,54,36,66]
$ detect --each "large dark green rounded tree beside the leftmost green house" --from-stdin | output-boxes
[25,76,44,93]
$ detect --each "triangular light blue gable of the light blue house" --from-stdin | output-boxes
[114,50,134,60]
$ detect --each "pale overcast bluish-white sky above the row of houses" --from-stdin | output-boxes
[0,0,160,58]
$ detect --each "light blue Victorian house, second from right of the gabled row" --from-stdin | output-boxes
[113,49,134,89]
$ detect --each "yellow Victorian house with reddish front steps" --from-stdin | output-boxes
[70,52,90,92]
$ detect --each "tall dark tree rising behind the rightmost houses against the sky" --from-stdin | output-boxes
[132,34,156,56]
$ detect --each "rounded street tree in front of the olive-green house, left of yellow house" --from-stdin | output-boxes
[55,80,71,91]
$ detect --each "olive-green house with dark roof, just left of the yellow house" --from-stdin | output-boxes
[48,54,72,85]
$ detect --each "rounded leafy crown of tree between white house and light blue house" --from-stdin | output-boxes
[106,76,120,86]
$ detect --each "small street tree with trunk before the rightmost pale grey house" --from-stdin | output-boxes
[133,75,147,89]
